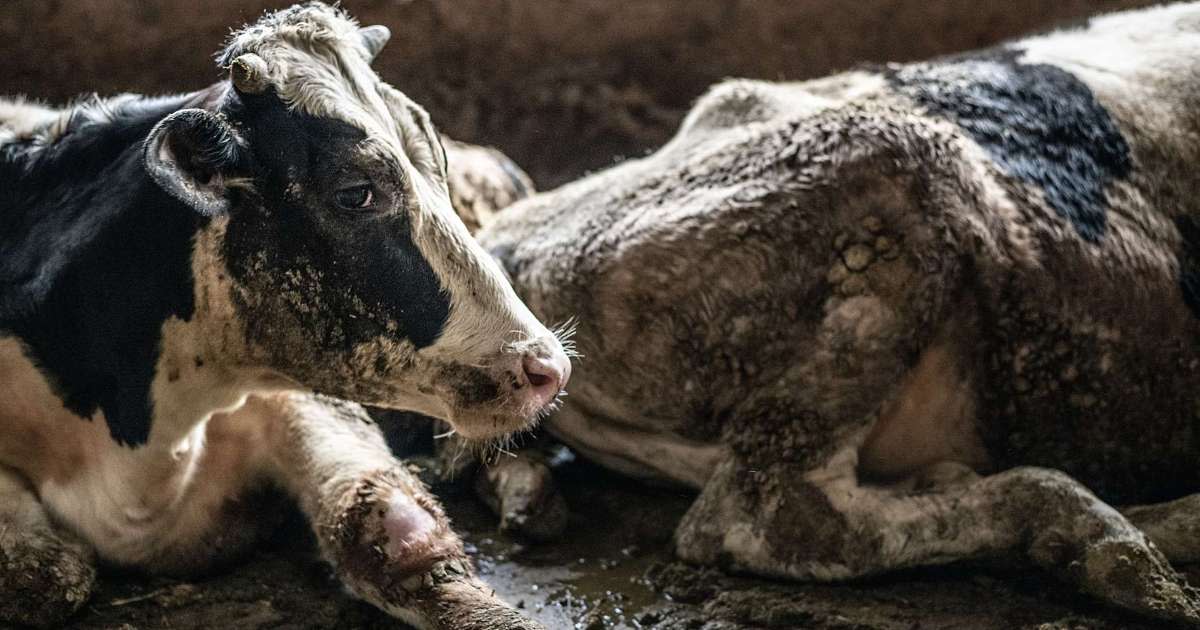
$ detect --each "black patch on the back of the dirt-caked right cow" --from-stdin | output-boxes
[884,48,1132,242]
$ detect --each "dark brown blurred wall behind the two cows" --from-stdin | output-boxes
[0,0,1154,187]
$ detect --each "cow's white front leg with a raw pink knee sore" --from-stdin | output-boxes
[260,396,540,630]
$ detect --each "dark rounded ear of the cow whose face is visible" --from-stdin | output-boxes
[144,109,245,216]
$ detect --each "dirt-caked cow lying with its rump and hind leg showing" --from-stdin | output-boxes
[479,4,1200,624]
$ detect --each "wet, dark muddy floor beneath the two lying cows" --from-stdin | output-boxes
[49,436,1180,630]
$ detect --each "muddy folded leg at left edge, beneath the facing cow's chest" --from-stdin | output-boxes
[0,467,96,626]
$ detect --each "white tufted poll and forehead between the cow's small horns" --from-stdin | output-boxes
[217,2,403,141]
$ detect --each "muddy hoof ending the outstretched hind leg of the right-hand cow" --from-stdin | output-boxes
[1078,540,1200,626]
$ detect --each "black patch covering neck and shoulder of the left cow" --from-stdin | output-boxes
[0,97,204,444]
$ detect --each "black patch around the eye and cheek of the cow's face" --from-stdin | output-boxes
[224,94,450,353]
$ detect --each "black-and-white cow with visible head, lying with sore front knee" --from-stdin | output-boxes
[0,4,570,629]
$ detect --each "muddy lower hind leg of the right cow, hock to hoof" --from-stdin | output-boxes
[676,448,1200,624]
